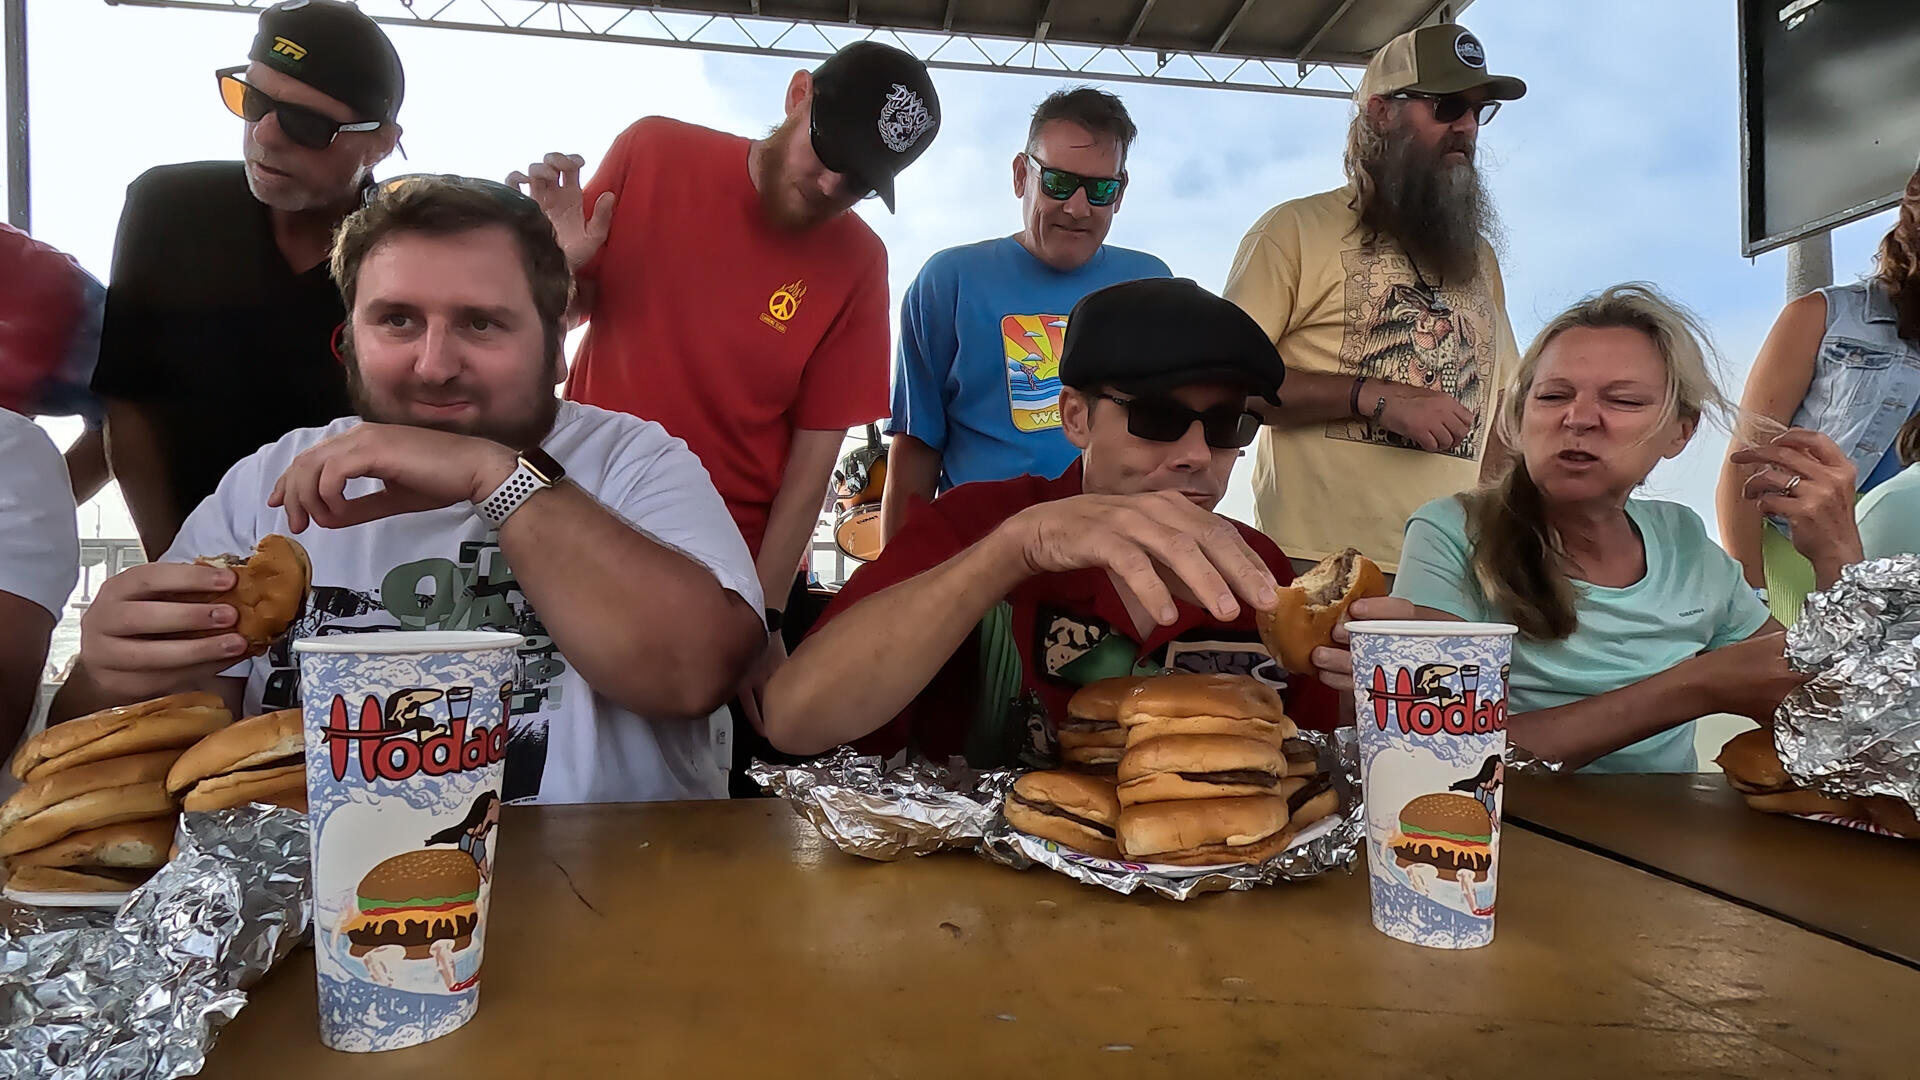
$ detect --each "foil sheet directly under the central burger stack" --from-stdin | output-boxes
[979,726,1367,899]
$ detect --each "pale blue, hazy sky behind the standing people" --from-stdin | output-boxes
[7,0,1891,536]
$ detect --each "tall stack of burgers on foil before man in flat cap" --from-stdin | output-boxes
[1006,675,1338,865]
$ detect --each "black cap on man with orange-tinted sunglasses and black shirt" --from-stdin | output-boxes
[248,0,407,123]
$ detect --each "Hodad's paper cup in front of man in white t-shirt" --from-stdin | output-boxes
[294,632,522,1051]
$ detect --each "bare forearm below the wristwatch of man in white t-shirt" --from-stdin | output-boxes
[499,484,766,715]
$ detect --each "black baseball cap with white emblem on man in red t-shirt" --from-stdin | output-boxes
[812,40,941,213]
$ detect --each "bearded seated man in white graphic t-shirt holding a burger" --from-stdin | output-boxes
[54,177,766,803]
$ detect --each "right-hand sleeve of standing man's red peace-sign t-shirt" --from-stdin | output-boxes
[791,238,893,430]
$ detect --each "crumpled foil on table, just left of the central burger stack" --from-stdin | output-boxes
[747,746,1020,863]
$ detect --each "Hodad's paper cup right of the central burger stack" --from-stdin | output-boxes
[1348,623,1515,949]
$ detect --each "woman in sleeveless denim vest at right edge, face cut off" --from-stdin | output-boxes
[1716,171,1920,625]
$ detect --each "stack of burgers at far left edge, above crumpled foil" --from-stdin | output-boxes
[0,694,232,894]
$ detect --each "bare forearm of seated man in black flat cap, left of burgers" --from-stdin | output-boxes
[760,528,1027,753]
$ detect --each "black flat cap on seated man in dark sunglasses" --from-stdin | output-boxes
[1060,277,1286,405]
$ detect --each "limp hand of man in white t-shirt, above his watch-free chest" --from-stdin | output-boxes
[267,423,516,534]
